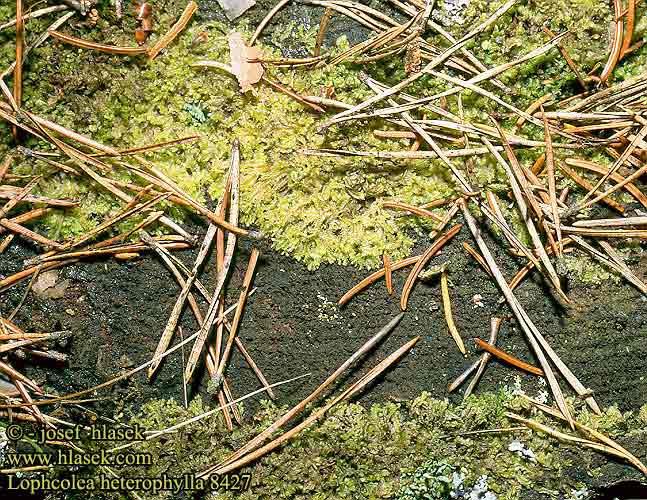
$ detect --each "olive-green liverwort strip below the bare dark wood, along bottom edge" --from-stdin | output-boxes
[41,389,647,500]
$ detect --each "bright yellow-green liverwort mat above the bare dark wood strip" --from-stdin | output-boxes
[0,1,644,276]
